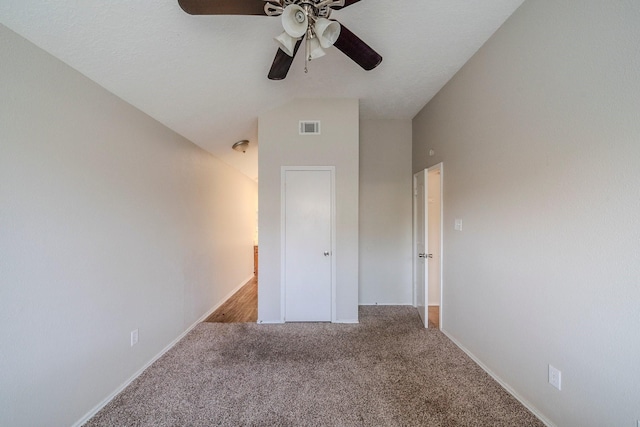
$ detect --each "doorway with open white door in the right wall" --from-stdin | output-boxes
[413,163,443,328]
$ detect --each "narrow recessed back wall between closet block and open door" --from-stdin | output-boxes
[359,120,413,304]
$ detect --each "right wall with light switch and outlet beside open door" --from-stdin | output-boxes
[413,0,640,426]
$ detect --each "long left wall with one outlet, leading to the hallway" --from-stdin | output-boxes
[0,26,257,426]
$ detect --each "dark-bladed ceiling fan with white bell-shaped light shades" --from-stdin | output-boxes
[178,0,382,80]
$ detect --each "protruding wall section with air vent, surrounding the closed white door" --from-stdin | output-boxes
[258,99,359,323]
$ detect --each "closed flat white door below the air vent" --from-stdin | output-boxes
[283,169,333,322]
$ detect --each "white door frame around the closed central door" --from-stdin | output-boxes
[280,166,336,323]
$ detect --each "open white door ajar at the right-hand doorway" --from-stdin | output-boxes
[413,170,429,327]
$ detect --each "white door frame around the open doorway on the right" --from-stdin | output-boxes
[411,162,444,329]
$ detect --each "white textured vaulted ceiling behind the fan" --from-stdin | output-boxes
[0,0,523,179]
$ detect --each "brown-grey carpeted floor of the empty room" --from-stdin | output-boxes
[85,306,543,427]
